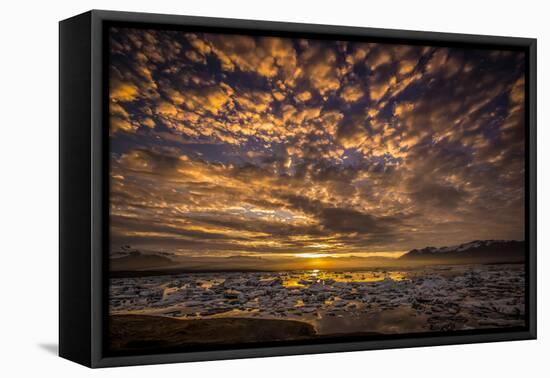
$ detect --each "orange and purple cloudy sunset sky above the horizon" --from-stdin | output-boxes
[109,28,525,257]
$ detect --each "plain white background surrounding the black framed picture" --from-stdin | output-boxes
[0,0,550,378]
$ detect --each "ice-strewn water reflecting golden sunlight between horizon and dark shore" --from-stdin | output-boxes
[110,265,525,335]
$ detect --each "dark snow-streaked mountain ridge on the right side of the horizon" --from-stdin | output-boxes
[399,240,525,264]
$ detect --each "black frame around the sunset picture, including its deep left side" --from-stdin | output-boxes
[59,10,537,368]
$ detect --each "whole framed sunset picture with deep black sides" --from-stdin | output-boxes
[60,11,536,367]
